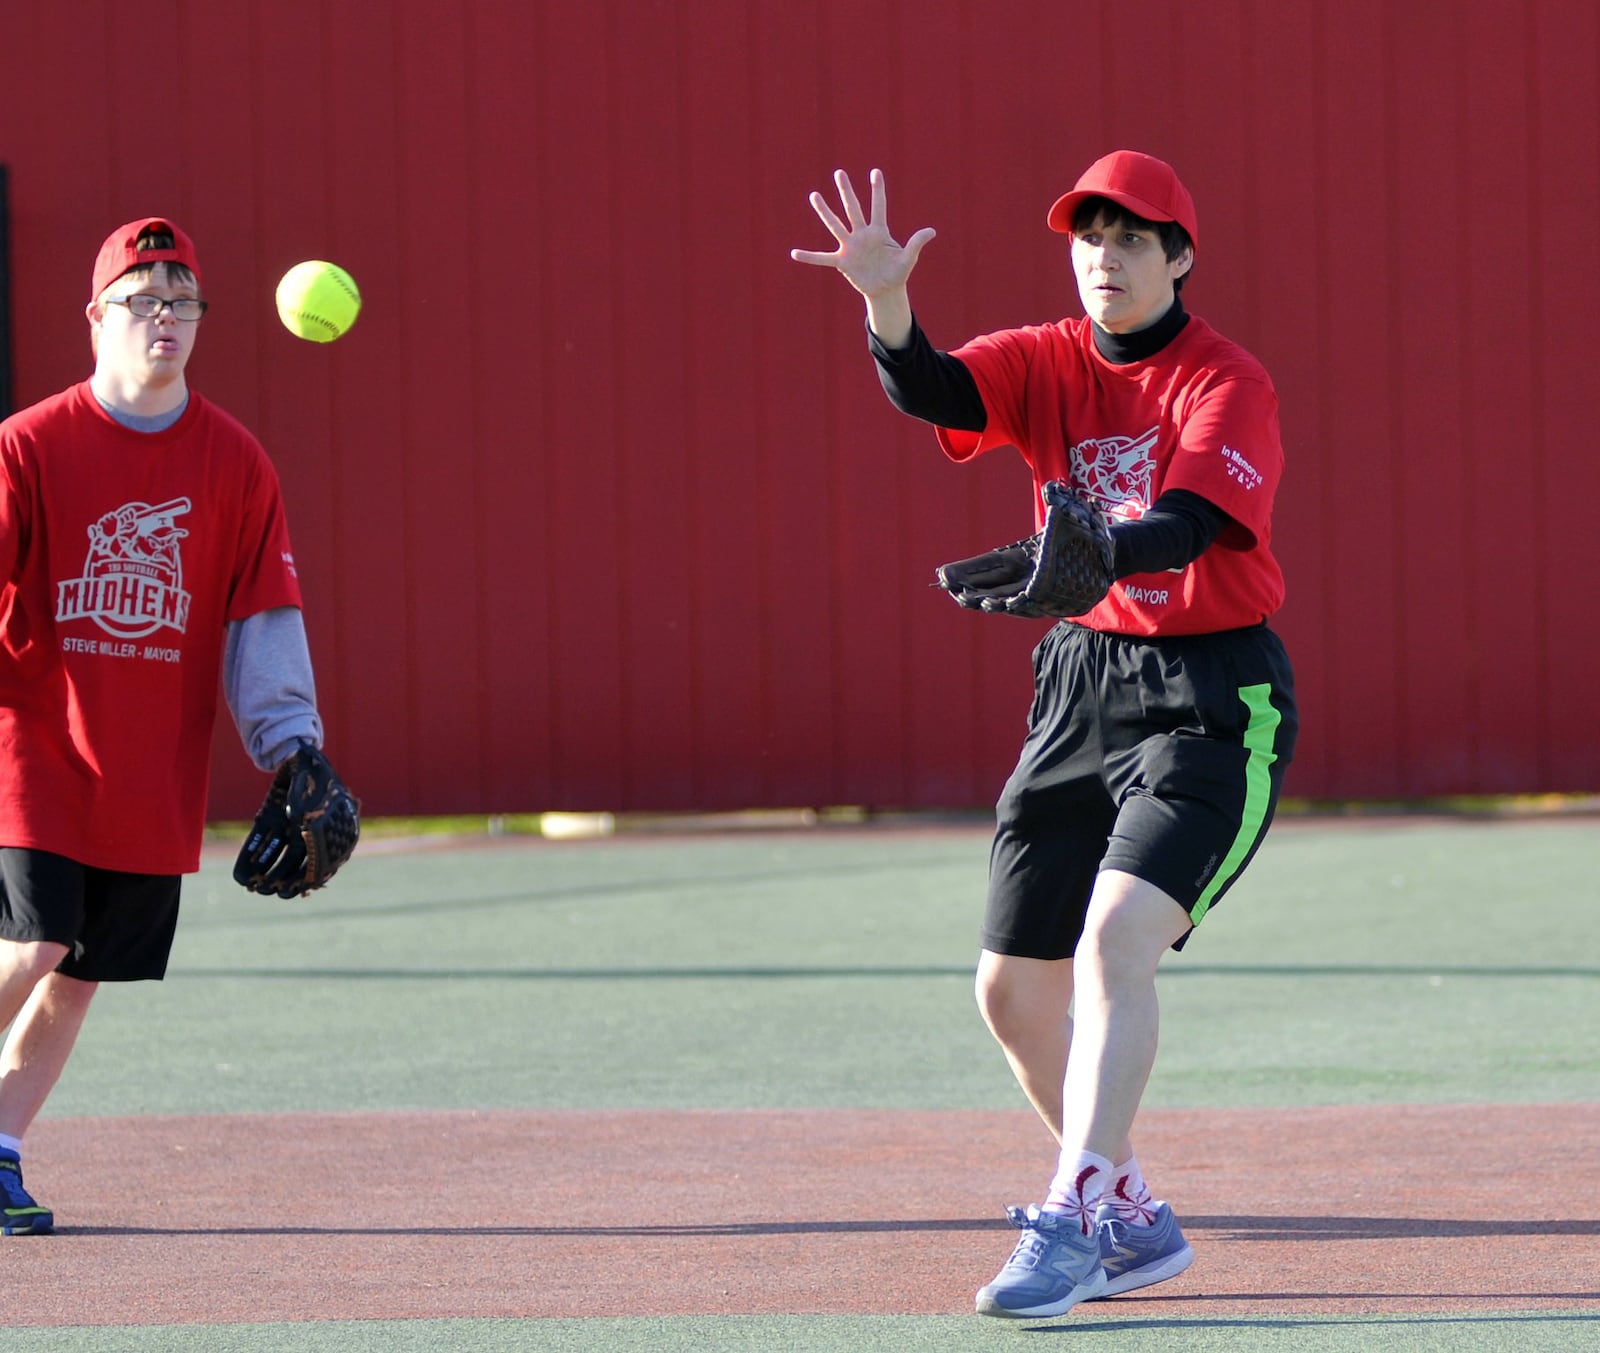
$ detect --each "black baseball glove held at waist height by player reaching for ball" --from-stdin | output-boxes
[934,480,1115,619]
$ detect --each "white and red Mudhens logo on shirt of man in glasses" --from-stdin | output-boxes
[56,497,192,638]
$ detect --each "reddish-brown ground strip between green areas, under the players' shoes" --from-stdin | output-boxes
[0,1104,1600,1326]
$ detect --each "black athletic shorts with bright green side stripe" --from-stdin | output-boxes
[982,622,1299,960]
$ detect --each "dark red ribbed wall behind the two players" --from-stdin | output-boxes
[0,0,1600,816]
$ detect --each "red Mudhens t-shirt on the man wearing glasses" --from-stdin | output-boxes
[0,382,301,873]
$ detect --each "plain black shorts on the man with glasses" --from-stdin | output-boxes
[0,846,182,982]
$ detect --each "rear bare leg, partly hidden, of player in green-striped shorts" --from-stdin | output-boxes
[976,948,1072,1143]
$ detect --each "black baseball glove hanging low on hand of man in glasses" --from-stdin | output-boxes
[234,742,362,897]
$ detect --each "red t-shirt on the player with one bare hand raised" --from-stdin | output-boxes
[938,315,1283,635]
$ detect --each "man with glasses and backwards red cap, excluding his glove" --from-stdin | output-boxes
[0,218,334,1235]
